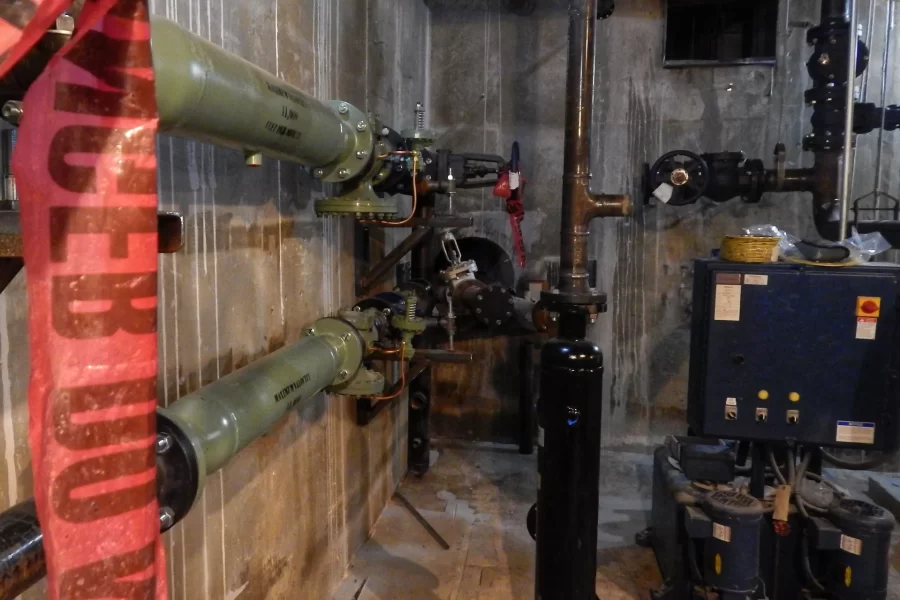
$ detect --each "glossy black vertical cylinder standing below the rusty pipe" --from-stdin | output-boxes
[535,312,603,600]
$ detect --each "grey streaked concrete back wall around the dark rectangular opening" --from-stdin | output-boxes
[429,0,897,446]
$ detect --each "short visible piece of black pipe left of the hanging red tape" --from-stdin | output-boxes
[0,500,47,600]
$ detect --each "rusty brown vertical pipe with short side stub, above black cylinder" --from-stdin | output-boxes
[559,0,631,296]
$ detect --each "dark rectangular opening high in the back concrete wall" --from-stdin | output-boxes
[665,0,778,67]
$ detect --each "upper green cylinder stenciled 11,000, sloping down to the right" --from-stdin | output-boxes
[151,17,374,181]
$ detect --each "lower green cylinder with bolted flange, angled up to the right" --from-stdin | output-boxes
[159,318,366,493]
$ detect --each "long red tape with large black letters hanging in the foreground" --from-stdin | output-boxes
[13,0,166,600]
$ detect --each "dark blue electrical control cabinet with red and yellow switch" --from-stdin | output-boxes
[688,259,900,451]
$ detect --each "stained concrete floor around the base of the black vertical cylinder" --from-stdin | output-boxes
[333,442,900,600]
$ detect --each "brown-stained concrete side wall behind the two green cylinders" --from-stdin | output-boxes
[0,0,428,600]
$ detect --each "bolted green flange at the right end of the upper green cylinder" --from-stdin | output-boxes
[312,100,375,183]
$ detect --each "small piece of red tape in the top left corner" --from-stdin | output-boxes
[0,0,72,77]
